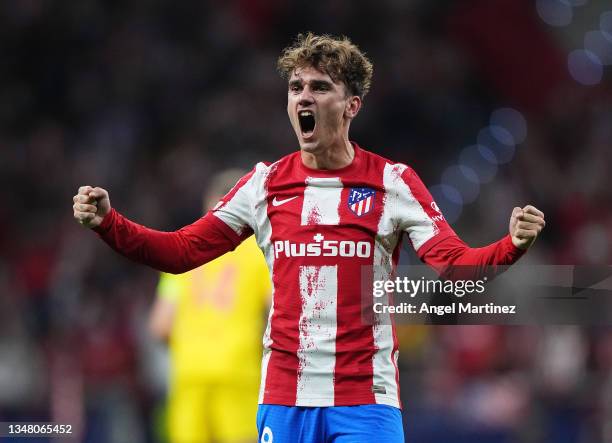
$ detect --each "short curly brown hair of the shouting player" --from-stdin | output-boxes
[276,32,374,98]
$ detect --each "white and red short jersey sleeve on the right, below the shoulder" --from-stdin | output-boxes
[397,167,456,255]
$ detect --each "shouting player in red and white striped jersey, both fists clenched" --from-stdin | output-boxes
[73,34,544,443]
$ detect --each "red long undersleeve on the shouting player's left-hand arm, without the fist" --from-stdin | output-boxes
[95,209,240,274]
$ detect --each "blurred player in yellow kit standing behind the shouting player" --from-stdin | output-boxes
[150,170,271,443]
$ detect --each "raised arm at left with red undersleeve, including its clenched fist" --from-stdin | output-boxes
[73,186,252,274]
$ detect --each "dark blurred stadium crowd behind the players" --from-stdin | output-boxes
[0,0,612,443]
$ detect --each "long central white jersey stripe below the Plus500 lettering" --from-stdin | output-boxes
[295,266,338,406]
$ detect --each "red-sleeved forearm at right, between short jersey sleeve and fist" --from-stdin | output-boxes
[419,236,525,279]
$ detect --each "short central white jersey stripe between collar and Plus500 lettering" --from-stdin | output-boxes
[302,177,342,226]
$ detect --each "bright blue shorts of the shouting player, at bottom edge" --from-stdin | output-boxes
[257,405,404,443]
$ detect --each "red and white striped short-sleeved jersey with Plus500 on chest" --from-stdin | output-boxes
[213,145,455,407]
